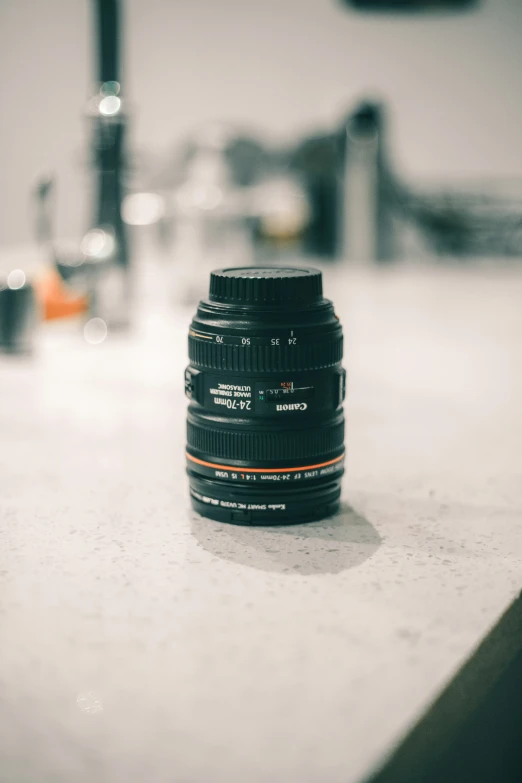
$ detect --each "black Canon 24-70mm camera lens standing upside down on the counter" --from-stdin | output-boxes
[185,267,345,525]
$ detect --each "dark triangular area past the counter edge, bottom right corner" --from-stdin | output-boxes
[365,597,522,783]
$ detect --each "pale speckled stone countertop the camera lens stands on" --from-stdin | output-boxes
[0,268,522,783]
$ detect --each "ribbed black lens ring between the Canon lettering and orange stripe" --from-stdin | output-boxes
[187,421,344,462]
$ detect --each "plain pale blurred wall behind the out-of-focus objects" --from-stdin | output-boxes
[0,0,522,244]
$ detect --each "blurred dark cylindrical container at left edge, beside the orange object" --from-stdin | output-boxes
[0,269,36,354]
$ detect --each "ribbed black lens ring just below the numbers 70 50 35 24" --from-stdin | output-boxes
[189,335,343,372]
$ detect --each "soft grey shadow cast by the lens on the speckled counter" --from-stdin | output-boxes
[191,504,381,576]
